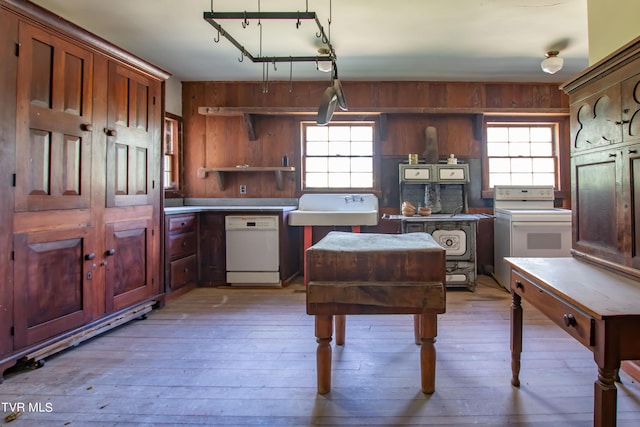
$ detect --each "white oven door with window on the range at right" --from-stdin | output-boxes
[511,221,571,258]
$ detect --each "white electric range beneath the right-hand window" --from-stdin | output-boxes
[493,186,571,290]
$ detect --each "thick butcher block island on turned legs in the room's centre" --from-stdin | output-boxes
[306,231,446,394]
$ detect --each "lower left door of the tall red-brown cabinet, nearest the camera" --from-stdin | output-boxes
[14,227,95,348]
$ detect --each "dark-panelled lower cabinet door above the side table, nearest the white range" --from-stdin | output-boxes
[571,147,626,264]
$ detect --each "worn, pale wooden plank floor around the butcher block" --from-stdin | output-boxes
[0,276,640,427]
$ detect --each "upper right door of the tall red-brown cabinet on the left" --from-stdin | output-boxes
[104,62,161,207]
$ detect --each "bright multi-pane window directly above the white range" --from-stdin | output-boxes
[486,122,558,189]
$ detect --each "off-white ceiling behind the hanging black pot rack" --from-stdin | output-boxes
[32,0,588,82]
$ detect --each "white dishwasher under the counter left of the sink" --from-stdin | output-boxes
[224,215,281,286]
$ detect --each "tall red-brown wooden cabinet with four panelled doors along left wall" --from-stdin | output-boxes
[0,0,168,382]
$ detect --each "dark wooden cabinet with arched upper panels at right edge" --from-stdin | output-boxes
[562,37,640,379]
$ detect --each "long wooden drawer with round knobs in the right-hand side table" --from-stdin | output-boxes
[511,270,595,347]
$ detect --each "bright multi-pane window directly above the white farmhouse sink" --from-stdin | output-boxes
[302,122,374,189]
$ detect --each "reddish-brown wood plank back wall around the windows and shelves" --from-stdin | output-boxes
[182,82,569,211]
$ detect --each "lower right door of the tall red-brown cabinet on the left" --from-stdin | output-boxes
[104,219,159,313]
